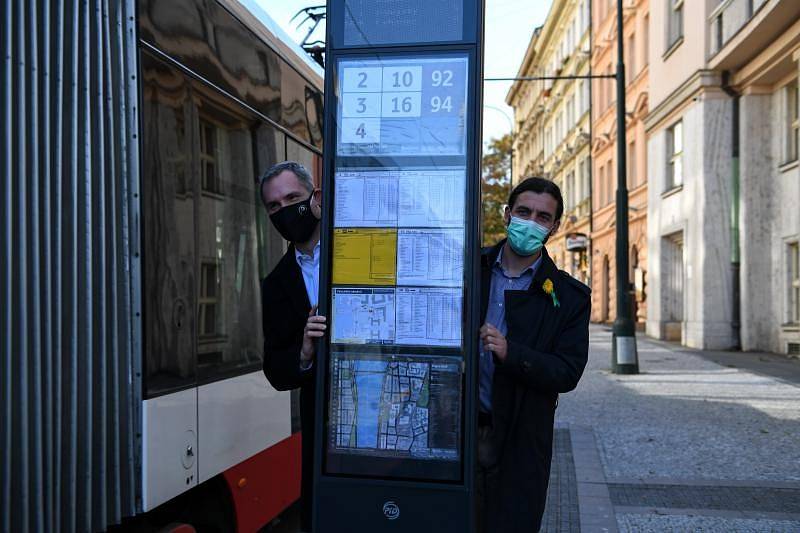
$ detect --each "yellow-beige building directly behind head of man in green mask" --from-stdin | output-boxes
[506,0,591,284]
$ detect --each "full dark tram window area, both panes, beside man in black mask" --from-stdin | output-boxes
[141,53,286,397]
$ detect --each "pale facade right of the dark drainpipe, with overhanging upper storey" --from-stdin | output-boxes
[707,0,800,354]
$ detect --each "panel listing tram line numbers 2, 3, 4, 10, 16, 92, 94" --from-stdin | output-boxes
[337,56,467,156]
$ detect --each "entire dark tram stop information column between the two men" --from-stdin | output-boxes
[314,0,483,533]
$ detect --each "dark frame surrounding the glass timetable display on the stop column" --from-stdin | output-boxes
[314,8,483,530]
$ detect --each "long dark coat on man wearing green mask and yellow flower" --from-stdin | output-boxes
[481,241,591,533]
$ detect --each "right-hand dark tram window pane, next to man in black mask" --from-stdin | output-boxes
[196,100,263,383]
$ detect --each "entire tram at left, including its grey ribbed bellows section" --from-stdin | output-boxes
[0,0,323,532]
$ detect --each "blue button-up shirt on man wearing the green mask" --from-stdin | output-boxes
[478,248,542,413]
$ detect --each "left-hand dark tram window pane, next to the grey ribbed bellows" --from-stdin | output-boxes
[141,54,197,396]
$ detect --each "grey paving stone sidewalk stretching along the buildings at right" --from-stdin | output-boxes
[542,326,800,532]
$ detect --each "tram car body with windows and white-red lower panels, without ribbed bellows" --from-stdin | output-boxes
[134,0,322,531]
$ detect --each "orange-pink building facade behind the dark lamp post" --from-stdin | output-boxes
[591,0,650,328]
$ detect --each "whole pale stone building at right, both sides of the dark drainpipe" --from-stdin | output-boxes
[645,0,800,352]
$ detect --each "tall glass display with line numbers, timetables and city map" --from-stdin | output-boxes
[324,52,469,481]
